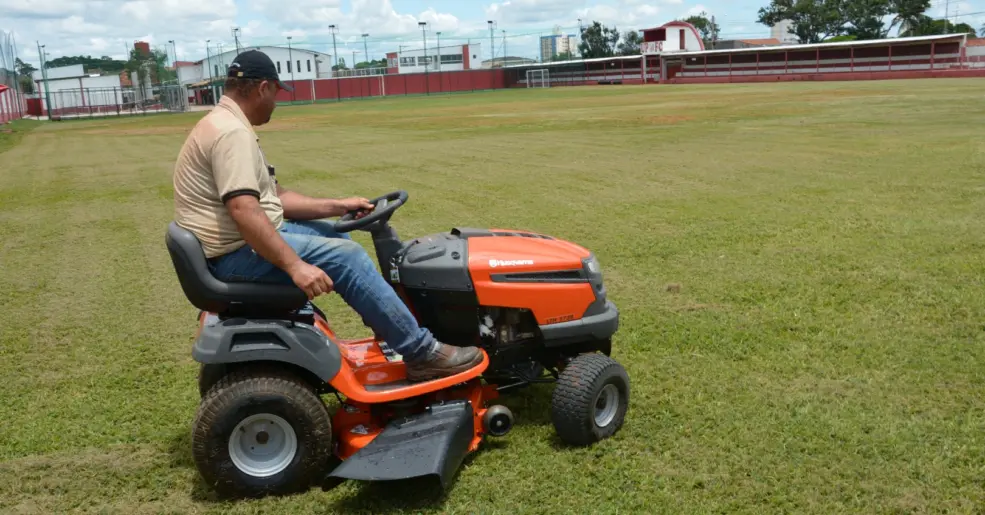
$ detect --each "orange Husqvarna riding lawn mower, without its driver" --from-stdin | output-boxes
[166,191,629,497]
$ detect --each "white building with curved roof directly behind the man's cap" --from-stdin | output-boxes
[178,46,332,86]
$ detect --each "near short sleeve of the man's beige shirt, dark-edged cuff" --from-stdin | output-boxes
[212,130,260,203]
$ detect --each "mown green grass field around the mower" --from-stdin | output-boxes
[0,79,985,513]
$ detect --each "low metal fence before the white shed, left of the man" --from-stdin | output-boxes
[41,85,188,120]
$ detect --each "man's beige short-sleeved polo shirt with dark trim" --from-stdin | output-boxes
[174,96,284,258]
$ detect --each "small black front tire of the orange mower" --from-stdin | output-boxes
[551,354,629,446]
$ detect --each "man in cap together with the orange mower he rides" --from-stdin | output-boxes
[166,50,629,496]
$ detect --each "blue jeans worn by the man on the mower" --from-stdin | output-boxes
[212,220,435,361]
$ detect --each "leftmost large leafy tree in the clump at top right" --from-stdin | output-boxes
[758,0,840,43]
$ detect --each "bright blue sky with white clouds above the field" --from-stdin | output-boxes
[0,0,985,66]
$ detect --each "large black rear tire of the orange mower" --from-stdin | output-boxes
[192,367,332,498]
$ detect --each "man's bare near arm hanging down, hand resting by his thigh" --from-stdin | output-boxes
[226,195,333,300]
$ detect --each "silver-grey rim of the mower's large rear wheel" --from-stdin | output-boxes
[229,413,298,477]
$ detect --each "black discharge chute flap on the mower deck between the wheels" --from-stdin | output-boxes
[329,401,475,488]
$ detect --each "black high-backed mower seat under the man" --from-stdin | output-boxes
[165,222,308,316]
